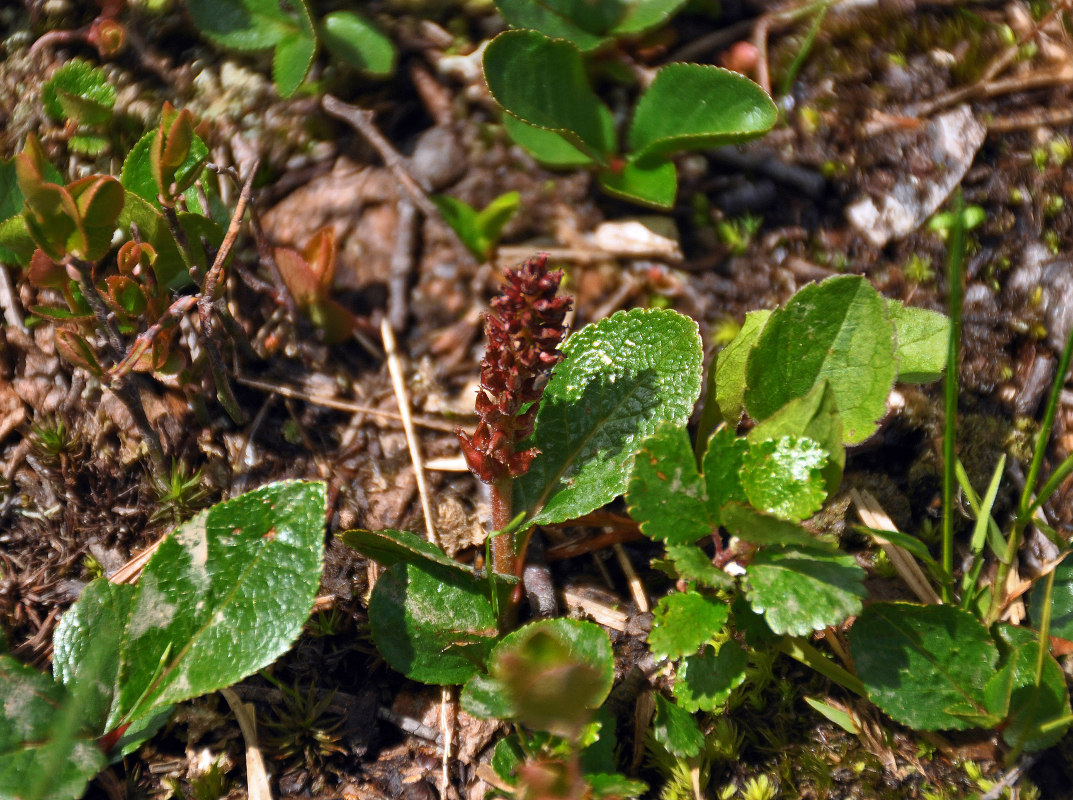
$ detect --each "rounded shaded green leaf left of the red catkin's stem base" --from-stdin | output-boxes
[369,561,498,685]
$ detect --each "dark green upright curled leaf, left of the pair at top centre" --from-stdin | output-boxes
[484,30,617,162]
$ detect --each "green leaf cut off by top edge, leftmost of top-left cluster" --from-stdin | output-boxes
[187,0,298,50]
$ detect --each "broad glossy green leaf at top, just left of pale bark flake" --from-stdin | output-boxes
[629,63,778,161]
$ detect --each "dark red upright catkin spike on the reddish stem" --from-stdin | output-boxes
[457,255,571,484]
